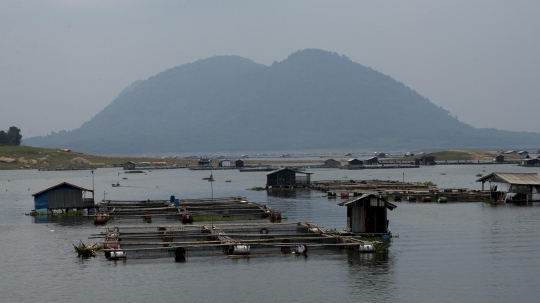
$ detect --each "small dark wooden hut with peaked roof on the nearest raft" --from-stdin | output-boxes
[339,194,397,235]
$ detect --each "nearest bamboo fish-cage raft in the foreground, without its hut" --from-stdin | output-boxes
[89,222,382,261]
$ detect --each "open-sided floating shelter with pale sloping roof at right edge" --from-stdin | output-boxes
[476,173,540,202]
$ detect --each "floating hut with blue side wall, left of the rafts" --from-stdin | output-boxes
[32,182,94,212]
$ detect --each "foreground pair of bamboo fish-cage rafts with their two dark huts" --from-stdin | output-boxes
[34,182,396,261]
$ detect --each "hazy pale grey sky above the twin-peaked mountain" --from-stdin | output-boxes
[0,0,540,137]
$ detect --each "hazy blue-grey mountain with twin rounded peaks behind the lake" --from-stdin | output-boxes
[23,49,540,154]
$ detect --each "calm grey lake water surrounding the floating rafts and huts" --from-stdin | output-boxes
[0,165,540,302]
